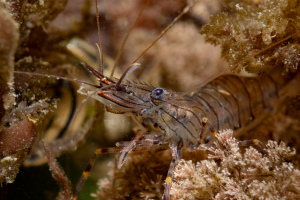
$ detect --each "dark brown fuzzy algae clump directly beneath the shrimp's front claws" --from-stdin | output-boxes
[92,151,170,200]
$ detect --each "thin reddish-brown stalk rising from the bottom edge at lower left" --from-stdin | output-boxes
[44,142,72,200]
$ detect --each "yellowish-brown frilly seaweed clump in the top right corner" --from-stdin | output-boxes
[200,0,300,73]
